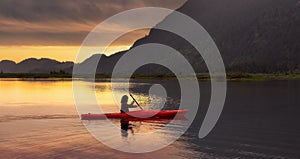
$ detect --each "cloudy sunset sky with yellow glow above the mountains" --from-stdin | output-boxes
[0,0,186,62]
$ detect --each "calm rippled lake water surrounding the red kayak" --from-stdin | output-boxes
[0,79,300,158]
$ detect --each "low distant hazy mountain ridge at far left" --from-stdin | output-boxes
[0,58,74,73]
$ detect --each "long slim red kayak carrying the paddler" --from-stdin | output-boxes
[81,110,188,120]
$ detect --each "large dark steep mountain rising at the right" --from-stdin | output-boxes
[88,0,300,73]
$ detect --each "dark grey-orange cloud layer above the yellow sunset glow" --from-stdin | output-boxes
[0,0,185,45]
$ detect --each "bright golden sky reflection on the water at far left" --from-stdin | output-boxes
[0,80,73,106]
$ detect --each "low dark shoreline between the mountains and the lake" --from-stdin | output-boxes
[0,72,300,81]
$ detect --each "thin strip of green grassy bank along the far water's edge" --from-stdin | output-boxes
[0,73,300,81]
